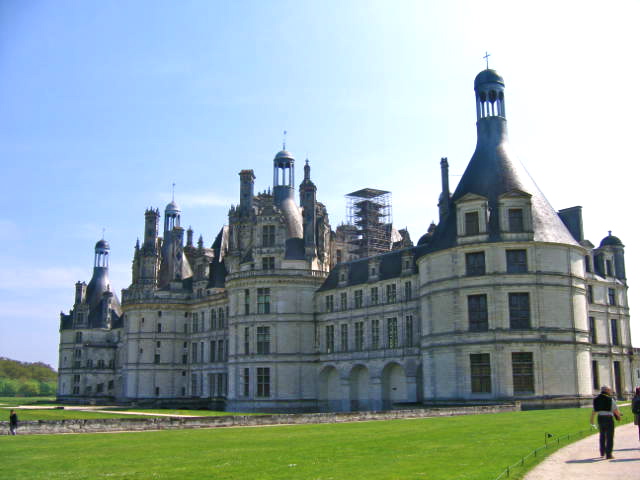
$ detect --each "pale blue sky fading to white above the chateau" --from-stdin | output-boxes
[0,0,640,367]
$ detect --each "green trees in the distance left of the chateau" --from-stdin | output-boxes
[0,357,58,397]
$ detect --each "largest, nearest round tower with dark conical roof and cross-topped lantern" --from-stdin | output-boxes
[417,69,593,405]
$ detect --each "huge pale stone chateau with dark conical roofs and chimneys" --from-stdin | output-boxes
[58,69,640,412]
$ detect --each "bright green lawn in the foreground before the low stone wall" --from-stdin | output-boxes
[0,407,632,480]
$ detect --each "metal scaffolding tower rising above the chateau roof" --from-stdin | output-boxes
[345,188,393,258]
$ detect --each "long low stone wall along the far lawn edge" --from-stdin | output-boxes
[0,403,520,435]
